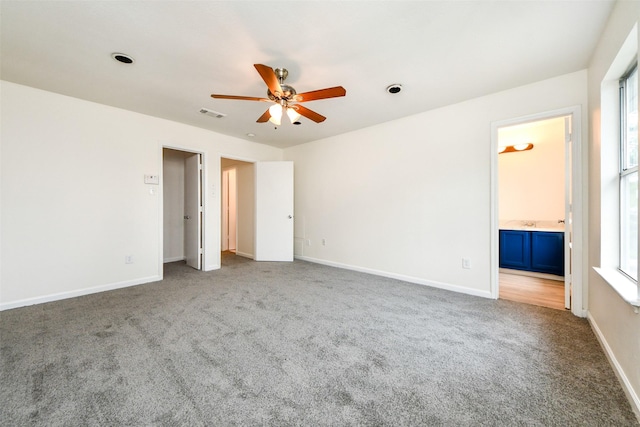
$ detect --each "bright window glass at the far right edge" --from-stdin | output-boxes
[620,65,638,281]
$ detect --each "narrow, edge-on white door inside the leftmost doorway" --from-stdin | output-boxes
[184,154,202,270]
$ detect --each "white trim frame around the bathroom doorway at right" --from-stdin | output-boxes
[490,105,587,317]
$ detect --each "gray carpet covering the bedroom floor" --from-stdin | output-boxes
[0,255,638,426]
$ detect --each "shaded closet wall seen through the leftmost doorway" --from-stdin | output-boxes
[162,149,185,262]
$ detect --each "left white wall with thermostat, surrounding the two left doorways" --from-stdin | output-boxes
[0,81,282,309]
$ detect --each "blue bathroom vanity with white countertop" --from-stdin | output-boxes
[500,222,564,276]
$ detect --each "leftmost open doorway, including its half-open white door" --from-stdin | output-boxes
[162,148,204,270]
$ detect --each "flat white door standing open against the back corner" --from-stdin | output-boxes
[255,162,293,261]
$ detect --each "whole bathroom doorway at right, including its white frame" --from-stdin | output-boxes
[492,107,584,316]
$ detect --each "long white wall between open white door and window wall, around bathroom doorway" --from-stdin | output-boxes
[285,71,586,297]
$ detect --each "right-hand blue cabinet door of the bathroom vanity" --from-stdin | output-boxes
[531,231,564,276]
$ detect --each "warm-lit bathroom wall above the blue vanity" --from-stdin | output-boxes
[498,117,565,221]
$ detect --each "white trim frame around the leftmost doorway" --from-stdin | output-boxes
[158,142,208,280]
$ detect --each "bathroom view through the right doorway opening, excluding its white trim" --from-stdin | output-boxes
[498,117,569,309]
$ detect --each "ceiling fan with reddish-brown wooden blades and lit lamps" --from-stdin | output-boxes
[211,64,347,126]
